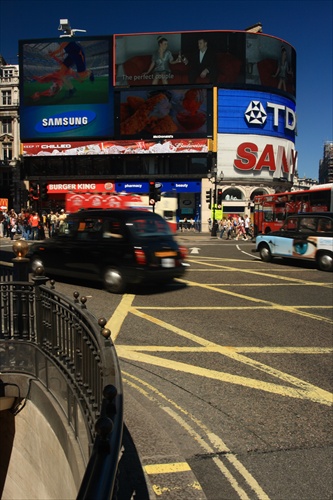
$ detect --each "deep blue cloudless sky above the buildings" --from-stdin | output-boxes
[0,0,333,179]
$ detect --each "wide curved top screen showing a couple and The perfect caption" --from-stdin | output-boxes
[114,31,296,97]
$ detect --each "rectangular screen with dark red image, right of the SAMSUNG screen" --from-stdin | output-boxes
[115,87,213,139]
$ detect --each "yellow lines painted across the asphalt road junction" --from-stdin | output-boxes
[106,268,333,499]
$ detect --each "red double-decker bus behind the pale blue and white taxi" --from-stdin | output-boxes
[253,183,333,236]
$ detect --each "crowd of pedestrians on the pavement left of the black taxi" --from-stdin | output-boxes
[0,209,66,240]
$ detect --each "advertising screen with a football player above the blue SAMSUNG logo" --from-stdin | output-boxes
[19,37,114,141]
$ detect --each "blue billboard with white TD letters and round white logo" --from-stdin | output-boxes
[217,89,297,141]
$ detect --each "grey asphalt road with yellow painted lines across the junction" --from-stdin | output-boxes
[0,234,333,500]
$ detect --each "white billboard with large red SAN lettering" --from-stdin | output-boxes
[217,134,297,181]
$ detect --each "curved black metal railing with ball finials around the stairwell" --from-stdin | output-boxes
[0,259,123,499]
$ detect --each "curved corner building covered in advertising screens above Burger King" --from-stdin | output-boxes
[1,26,316,229]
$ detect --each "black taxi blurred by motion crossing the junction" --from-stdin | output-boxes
[27,209,188,293]
